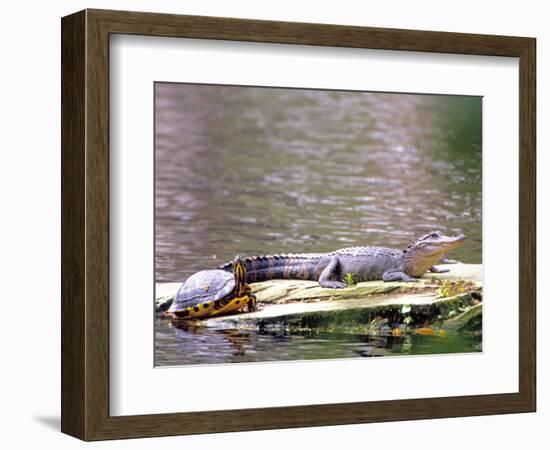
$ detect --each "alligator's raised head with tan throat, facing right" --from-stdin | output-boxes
[403,231,464,277]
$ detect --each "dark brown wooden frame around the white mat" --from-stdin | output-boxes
[61,10,536,440]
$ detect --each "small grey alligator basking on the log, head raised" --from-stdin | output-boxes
[220,231,465,289]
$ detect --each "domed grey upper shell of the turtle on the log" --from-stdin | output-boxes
[168,270,235,313]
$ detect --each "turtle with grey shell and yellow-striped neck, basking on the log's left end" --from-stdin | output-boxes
[167,256,257,319]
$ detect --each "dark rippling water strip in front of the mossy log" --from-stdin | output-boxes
[155,319,481,366]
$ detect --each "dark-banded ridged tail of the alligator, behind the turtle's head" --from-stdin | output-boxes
[220,253,324,283]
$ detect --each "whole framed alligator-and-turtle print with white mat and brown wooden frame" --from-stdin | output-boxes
[62,10,536,440]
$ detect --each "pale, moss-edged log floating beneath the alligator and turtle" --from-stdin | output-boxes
[156,264,482,331]
